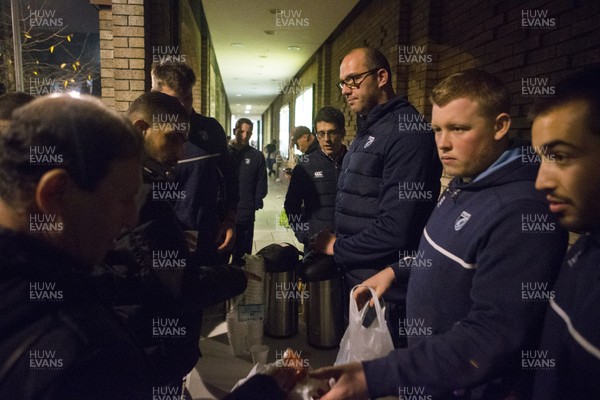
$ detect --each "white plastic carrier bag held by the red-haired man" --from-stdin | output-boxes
[335,285,394,365]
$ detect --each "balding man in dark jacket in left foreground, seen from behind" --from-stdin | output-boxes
[0,95,150,400]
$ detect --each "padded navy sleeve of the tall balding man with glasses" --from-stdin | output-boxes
[334,133,441,266]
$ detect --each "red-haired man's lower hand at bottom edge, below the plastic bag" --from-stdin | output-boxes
[308,362,369,400]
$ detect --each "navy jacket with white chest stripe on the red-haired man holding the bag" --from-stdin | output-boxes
[364,147,567,399]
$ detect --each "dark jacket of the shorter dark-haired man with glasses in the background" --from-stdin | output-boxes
[283,147,346,245]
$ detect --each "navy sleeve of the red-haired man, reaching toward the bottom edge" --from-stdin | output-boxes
[363,201,567,398]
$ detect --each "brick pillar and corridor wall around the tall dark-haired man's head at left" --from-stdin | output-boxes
[98,0,230,125]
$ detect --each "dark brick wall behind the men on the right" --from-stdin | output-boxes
[264,0,600,147]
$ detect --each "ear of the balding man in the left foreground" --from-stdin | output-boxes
[35,169,74,215]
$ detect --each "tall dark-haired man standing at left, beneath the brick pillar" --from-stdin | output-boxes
[152,62,239,265]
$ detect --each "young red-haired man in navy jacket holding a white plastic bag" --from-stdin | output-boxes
[312,70,567,400]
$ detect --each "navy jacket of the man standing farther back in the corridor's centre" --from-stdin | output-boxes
[229,146,268,223]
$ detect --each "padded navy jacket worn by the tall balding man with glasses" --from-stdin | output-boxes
[334,97,442,275]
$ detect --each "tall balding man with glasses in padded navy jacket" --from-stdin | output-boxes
[313,48,441,344]
